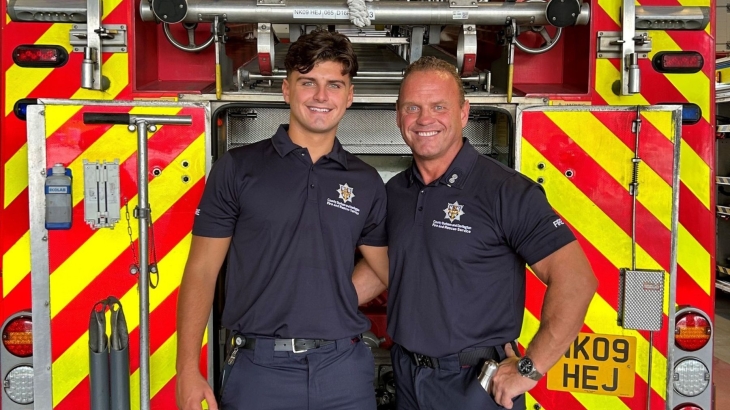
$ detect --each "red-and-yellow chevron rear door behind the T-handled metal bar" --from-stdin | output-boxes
[22,100,212,409]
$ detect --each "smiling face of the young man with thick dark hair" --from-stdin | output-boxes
[281,61,353,138]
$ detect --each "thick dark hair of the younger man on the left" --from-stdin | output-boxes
[284,29,358,79]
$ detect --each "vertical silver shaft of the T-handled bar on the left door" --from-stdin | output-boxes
[135,118,150,410]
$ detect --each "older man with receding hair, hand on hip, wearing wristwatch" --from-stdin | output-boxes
[384,57,597,410]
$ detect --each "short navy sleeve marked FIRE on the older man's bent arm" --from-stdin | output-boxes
[496,174,575,265]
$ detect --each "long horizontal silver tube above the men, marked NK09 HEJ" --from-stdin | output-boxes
[138,0,590,26]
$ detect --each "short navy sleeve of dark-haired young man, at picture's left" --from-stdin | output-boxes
[193,152,240,238]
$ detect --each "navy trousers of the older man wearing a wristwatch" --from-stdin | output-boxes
[390,345,525,410]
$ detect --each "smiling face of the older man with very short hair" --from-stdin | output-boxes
[396,70,469,172]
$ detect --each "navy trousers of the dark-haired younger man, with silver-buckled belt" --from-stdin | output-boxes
[220,338,375,410]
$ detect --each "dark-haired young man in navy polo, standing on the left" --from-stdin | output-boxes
[177,31,388,410]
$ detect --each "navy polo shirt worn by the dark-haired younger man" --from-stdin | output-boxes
[193,125,387,340]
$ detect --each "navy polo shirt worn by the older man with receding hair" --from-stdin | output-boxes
[386,139,575,357]
